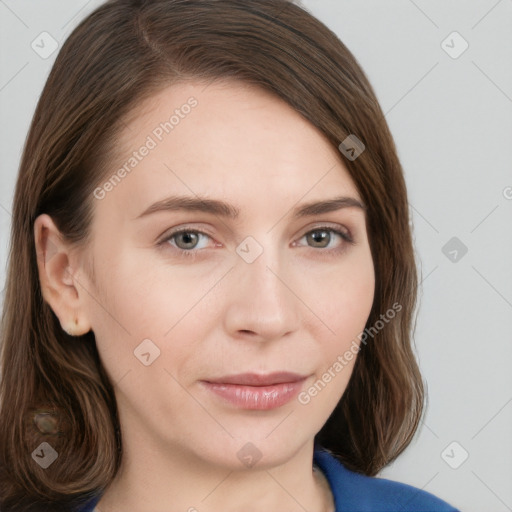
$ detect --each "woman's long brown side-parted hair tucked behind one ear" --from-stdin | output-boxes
[0,0,424,511]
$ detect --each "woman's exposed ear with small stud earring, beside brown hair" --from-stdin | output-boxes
[34,214,91,336]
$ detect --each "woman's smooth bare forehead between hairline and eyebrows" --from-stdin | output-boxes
[92,81,359,221]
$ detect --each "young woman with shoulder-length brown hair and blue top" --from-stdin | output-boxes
[0,0,455,512]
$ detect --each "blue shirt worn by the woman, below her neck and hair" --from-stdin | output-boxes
[77,445,459,512]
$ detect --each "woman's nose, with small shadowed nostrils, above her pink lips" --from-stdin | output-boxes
[224,243,300,342]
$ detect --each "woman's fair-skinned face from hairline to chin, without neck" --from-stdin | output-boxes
[78,82,374,466]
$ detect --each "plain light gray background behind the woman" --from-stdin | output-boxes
[0,0,512,512]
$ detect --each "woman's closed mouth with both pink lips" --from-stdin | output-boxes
[201,372,308,410]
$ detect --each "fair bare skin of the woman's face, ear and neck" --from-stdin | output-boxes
[34,81,375,512]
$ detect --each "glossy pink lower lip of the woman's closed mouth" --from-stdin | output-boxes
[202,378,306,411]
